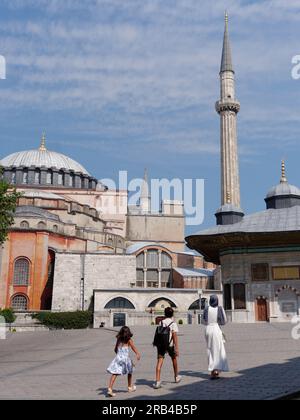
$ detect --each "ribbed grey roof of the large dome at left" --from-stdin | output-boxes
[0,149,89,175]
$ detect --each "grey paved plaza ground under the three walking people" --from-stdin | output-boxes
[0,324,300,400]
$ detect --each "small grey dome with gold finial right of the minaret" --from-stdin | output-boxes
[265,160,300,209]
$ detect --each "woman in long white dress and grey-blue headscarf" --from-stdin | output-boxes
[203,295,229,379]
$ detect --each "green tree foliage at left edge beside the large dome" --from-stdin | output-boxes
[0,168,21,245]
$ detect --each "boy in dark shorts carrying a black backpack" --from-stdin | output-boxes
[153,308,182,389]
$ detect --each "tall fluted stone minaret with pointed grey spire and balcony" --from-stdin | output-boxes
[216,12,243,224]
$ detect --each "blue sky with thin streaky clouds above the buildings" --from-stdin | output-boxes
[0,0,300,233]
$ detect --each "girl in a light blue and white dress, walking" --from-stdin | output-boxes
[107,327,141,397]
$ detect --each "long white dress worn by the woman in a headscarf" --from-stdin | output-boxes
[205,307,229,372]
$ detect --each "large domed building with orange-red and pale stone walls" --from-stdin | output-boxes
[0,136,220,326]
